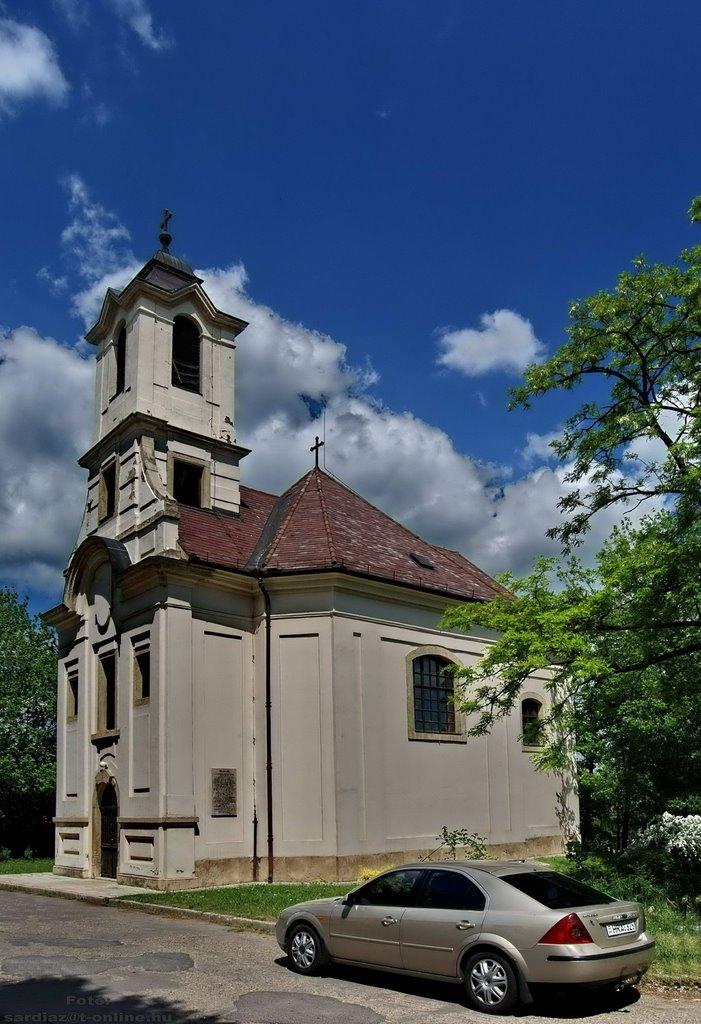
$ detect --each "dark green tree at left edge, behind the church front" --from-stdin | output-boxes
[0,587,56,854]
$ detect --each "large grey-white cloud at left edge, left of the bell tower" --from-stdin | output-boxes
[0,328,94,594]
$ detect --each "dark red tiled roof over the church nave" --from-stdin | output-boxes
[180,469,502,600]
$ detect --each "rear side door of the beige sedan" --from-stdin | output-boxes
[400,867,486,977]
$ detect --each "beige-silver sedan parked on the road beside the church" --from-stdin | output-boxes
[276,860,655,1014]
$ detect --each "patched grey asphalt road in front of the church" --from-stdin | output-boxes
[0,892,701,1024]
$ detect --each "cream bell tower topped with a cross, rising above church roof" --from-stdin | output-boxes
[78,211,248,563]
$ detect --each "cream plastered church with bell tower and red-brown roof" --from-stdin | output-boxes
[44,222,562,889]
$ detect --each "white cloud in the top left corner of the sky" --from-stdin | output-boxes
[0,18,69,113]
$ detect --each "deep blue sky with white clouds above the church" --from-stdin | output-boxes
[0,0,701,607]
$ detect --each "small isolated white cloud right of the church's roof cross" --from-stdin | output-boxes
[436,309,545,377]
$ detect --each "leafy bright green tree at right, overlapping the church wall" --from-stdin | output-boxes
[443,200,701,848]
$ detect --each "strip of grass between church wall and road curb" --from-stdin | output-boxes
[121,882,353,921]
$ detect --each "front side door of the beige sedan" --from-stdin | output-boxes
[328,868,423,968]
